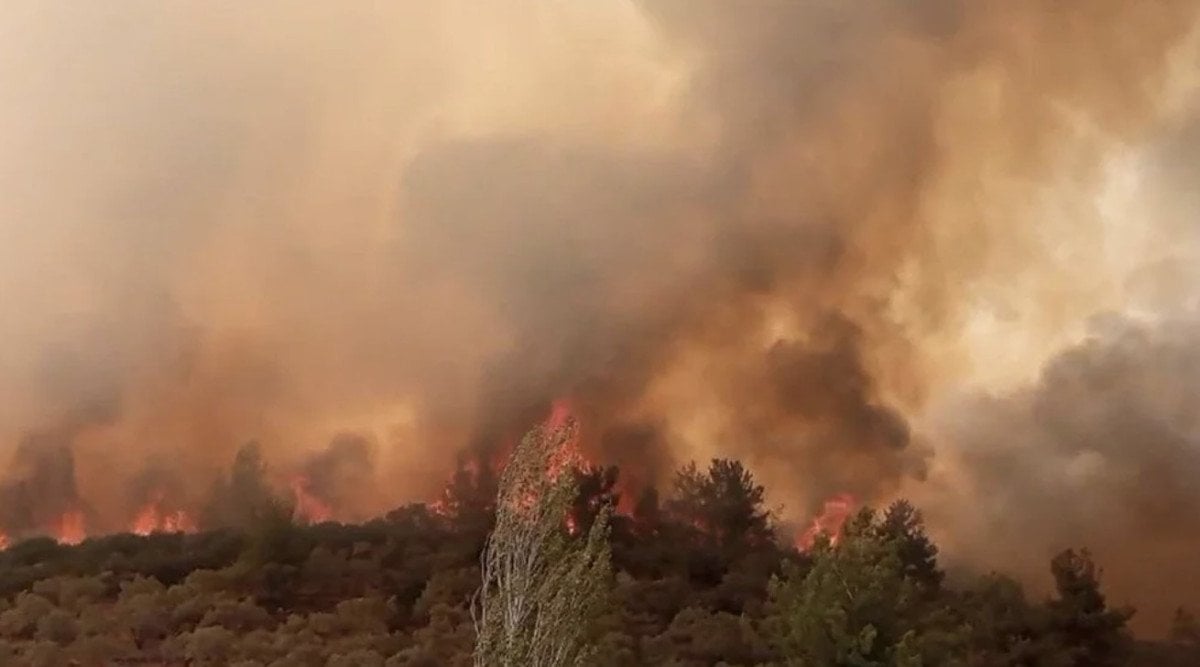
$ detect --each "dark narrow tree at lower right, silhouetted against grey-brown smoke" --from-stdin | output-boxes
[1049,549,1133,667]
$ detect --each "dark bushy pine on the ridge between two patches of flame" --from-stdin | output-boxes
[667,458,774,549]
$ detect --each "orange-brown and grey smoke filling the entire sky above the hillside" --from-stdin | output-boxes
[0,0,1200,627]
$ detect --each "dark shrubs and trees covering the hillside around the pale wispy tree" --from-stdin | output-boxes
[0,452,1200,667]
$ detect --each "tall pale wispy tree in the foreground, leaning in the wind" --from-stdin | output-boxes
[472,421,611,667]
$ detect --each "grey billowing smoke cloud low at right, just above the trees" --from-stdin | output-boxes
[926,313,1200,627]
